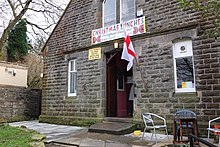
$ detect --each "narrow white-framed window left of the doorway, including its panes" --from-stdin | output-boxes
[68,60,77,96]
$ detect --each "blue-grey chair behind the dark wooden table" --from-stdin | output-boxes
[174,109,196,141]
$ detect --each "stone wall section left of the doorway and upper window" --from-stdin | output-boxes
[40,0,105,123]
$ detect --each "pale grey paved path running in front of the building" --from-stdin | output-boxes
[10,121,172,147]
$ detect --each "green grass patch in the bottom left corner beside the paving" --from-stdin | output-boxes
[0,124,42,147]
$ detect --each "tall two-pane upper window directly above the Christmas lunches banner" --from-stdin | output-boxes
[103,0,136,27]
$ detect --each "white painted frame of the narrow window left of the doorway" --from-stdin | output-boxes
[68,60,77,96]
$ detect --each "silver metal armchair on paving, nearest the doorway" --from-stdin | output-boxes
[142,113,169,143]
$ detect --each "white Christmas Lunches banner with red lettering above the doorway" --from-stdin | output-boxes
[92,16,146,44]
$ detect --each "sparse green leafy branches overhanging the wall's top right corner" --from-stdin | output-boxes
[177,0,220,37]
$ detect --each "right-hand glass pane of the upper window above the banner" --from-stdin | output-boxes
[121,0,135,21]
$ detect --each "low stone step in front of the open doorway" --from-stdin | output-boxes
[89,122,136,135]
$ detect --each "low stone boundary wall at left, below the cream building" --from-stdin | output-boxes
[0,86,41,122]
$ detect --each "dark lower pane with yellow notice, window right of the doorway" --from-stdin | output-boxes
[176,56,194,88]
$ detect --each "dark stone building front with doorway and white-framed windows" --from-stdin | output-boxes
[40,0,220,134]
